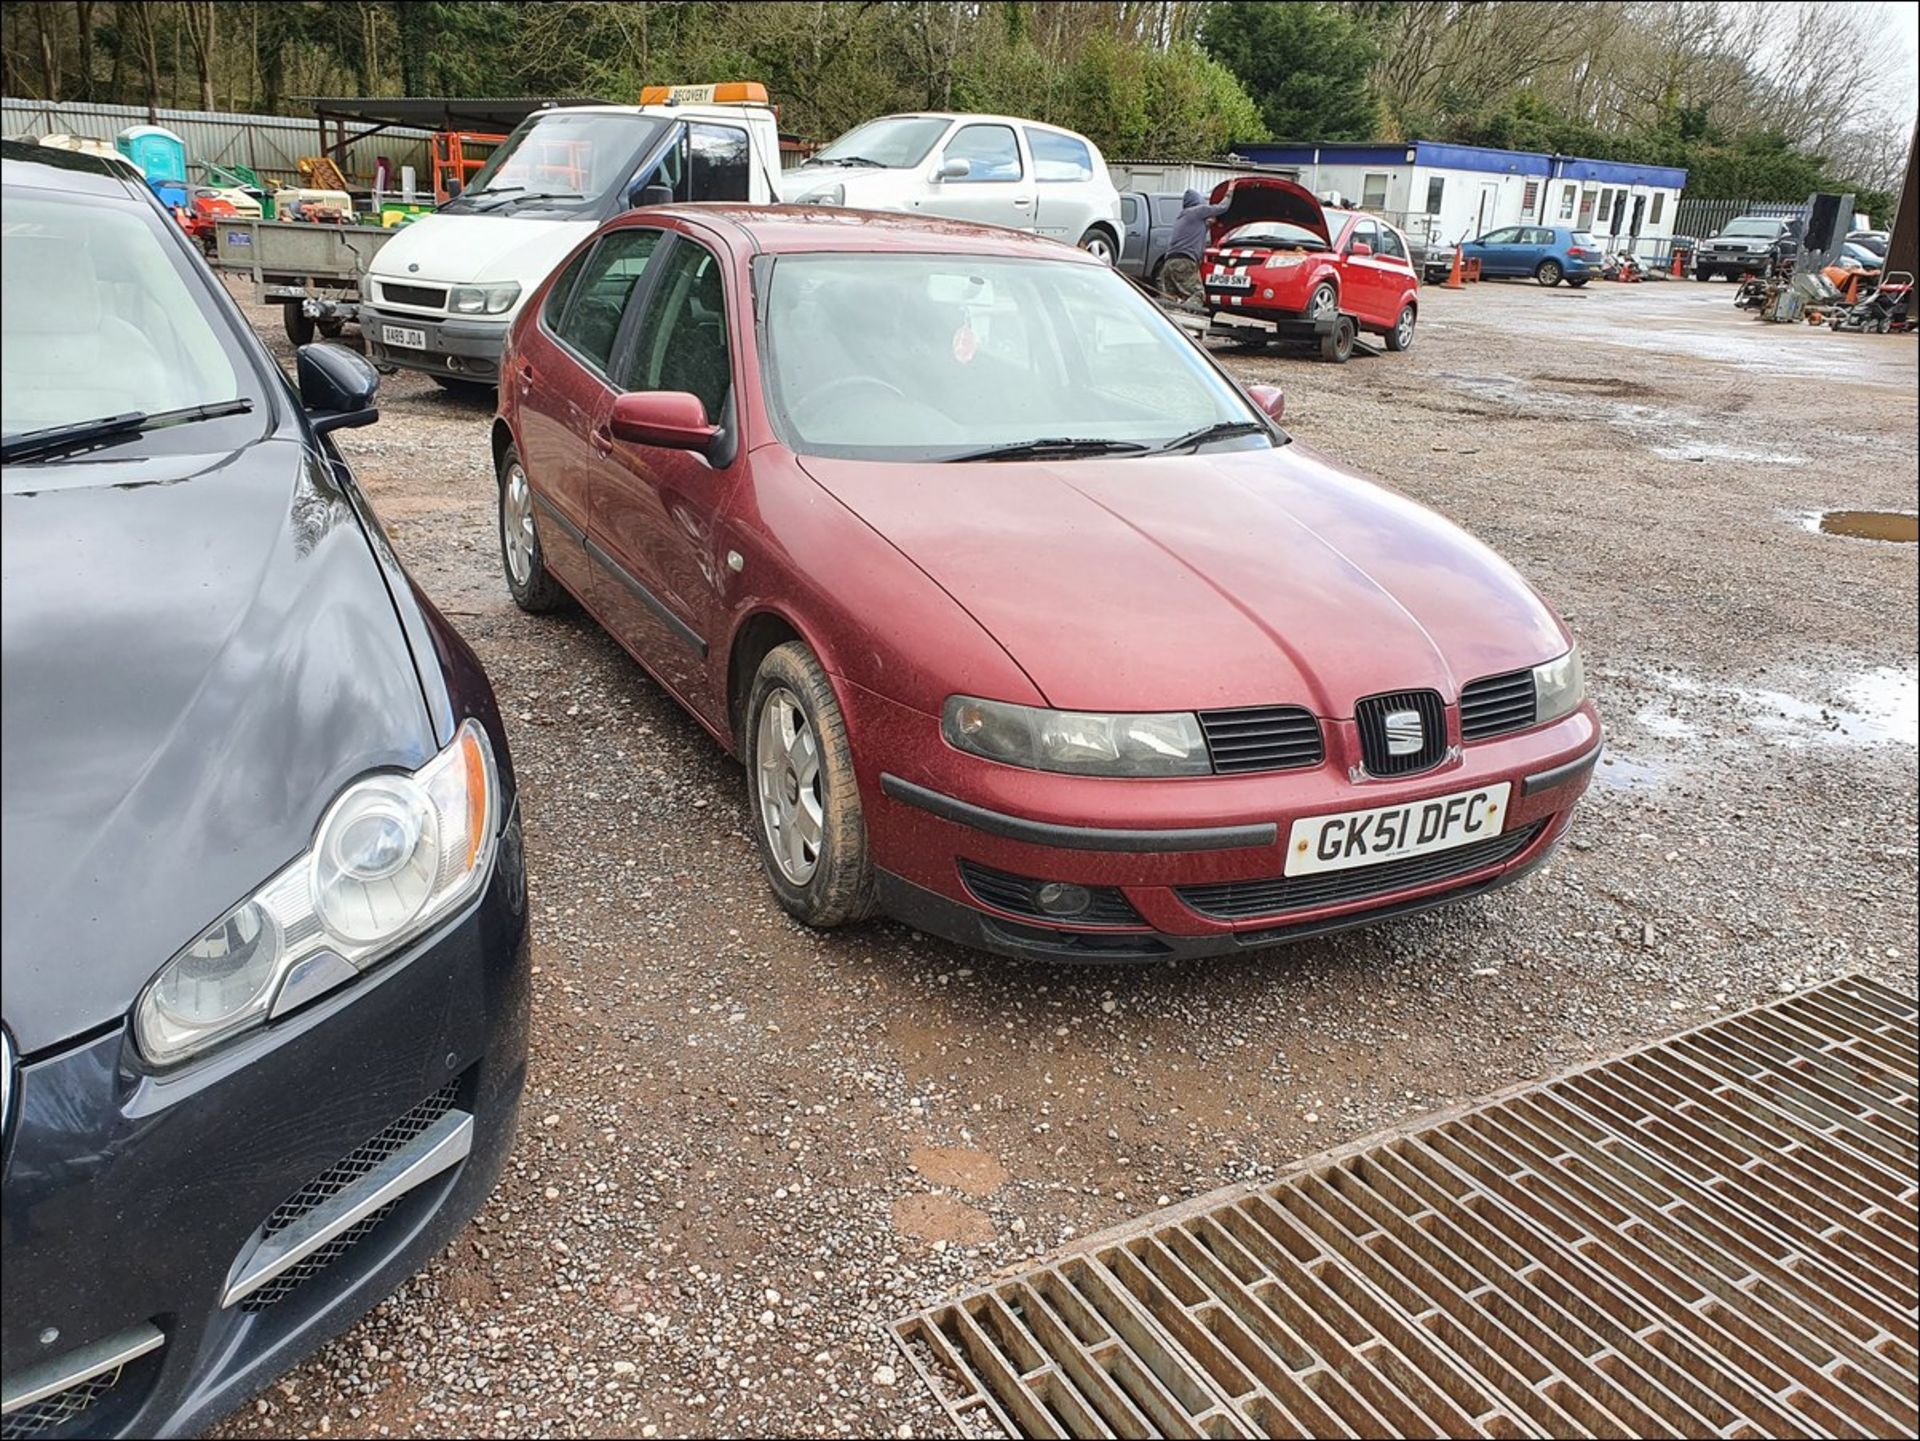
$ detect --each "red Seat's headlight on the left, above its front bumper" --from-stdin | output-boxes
[941,695,1213,775]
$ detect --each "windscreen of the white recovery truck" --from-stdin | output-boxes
[445,109,666,215]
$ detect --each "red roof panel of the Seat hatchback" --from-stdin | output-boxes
[624,203,1106,265]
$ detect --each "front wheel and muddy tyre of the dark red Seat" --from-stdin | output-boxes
[743,641,877,929]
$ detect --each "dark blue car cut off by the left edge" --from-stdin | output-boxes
[0,140,528,1441]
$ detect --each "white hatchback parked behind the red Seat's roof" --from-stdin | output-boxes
[780,111,1119,263]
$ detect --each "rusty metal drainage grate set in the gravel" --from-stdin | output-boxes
[895,977,1920,1437]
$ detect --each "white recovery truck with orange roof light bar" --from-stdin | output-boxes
[359,84,780,386]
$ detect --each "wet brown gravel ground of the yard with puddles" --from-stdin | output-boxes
[206,282,1916,1437]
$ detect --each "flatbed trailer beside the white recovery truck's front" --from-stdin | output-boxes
[213,219,396,345]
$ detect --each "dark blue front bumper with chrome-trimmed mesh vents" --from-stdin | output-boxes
[0,808,528,1441]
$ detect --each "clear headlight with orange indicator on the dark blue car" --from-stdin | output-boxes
[132,720,499,1065]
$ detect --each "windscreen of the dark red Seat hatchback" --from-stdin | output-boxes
[764,253,1260,461]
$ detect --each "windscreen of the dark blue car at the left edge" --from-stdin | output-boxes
[0,188,259,439]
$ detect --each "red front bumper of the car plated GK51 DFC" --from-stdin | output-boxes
[843,687,1601,961]
